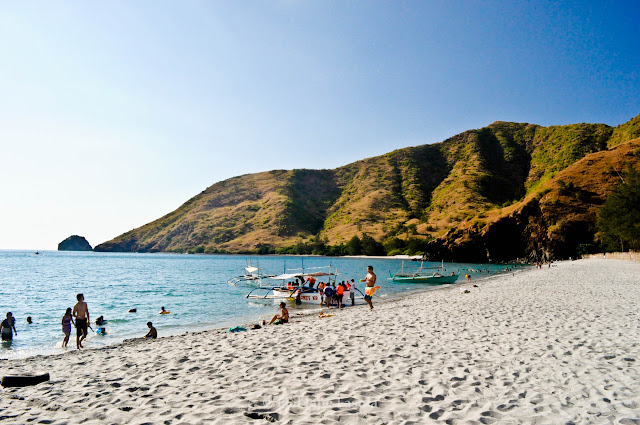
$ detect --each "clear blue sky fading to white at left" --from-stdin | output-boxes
[0,0,640,249]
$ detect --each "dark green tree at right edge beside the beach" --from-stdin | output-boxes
[597,167,640,251]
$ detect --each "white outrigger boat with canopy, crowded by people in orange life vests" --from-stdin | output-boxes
[246,266,363,304]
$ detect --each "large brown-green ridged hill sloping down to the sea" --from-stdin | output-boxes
[95,115,640,262]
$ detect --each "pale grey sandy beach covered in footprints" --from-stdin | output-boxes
[0,260,640,424]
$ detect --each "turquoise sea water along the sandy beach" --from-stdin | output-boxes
[0,251,520,358]
